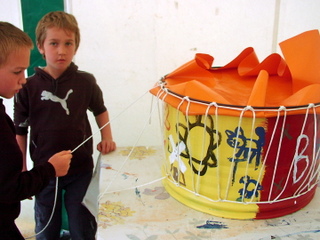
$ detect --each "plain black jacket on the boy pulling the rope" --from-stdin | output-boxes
[0,99,55,239]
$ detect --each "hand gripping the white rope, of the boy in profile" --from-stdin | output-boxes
[48,150,72,177]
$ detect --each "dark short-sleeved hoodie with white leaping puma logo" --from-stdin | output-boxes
[14,63,106,175]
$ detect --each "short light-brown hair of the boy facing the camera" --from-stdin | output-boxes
[36,11,80,51]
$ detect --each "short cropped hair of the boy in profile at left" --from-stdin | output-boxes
[0,21,33,66]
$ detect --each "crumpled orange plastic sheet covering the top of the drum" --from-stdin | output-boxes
[150,30,320,116]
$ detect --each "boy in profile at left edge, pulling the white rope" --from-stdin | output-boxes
[0,22,72,240]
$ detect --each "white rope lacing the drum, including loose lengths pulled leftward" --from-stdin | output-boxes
[26,81,320,239]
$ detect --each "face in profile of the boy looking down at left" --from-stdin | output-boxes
[0,48,30,98]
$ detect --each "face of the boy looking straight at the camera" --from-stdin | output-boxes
[38,27,76,78]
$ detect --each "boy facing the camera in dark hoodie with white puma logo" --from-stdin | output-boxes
[14,11,116,240]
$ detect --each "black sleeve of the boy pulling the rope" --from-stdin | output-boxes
[0,105,55,203]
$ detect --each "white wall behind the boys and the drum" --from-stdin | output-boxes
[0,0,320,146]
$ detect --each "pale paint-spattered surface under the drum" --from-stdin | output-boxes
[17,146,320,240]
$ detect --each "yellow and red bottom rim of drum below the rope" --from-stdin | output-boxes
[162,178,317,220]
